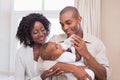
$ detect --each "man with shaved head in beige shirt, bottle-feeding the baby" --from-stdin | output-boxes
[39,6,111,80]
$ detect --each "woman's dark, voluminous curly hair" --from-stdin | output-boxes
[16,13,50,47]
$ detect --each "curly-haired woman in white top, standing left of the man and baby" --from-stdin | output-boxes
[15,13,57,80]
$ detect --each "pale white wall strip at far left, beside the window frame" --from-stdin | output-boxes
[0,0,10,71]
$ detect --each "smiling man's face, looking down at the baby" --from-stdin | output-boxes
[60,11,80,36]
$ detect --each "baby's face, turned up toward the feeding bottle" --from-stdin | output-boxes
[48,42,63,59]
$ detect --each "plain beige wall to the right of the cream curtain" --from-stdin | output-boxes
[101,0,120,80]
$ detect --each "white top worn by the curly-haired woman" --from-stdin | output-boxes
[15,46,42,80]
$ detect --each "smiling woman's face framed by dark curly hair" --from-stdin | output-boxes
[31,21,46,44]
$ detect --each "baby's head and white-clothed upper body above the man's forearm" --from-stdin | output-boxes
[40,42,76,63]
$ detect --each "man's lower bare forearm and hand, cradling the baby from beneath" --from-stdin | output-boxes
[52,62,92,80]
